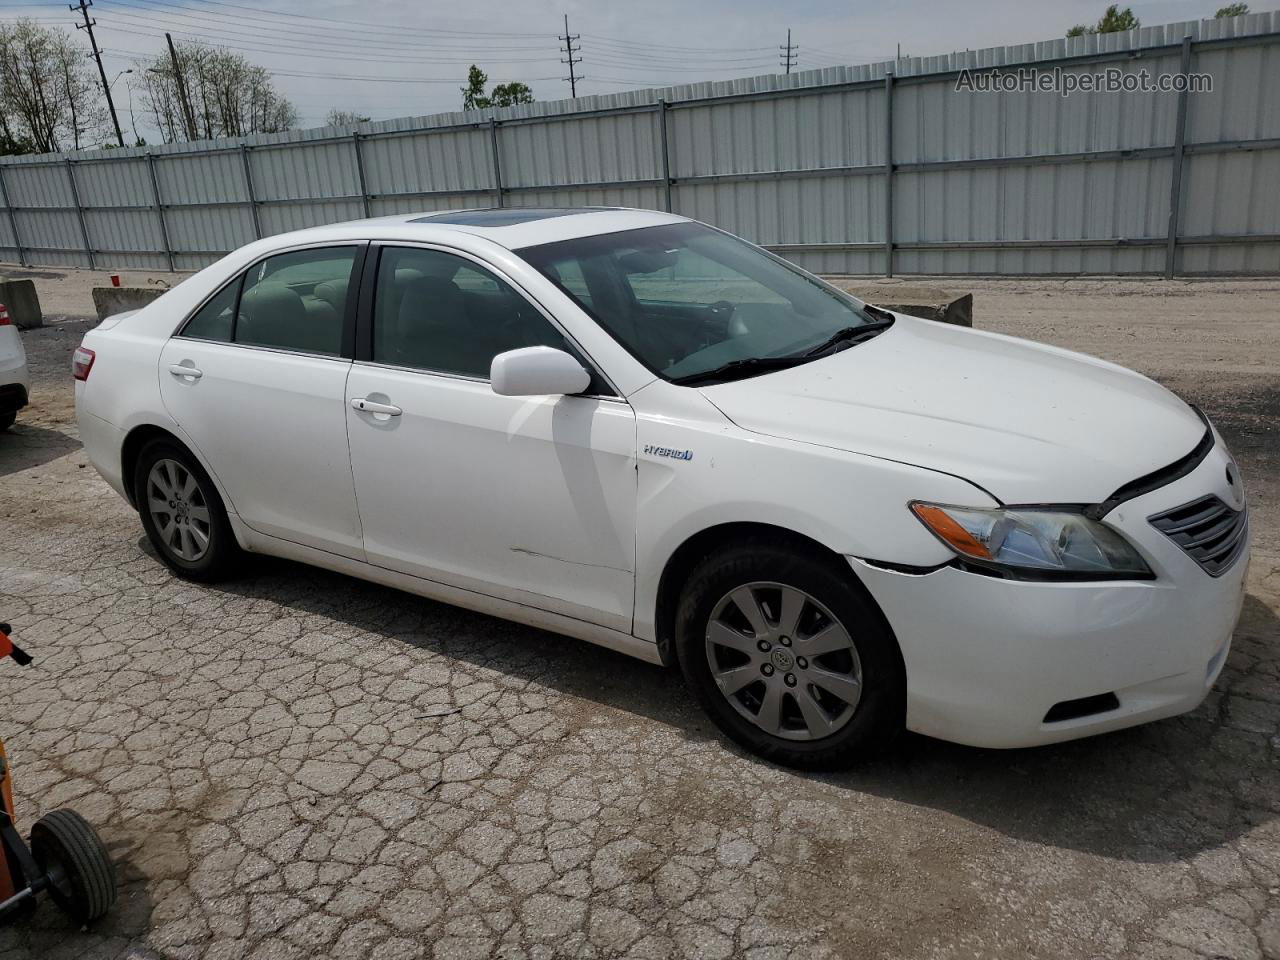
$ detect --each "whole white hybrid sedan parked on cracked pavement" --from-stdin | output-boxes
[74,209,1249,768]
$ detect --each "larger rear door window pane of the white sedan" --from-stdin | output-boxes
[233,247,358,356]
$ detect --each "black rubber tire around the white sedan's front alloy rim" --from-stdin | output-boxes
[676,539,906,771]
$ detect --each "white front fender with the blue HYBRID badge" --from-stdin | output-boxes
[631,381,996,640]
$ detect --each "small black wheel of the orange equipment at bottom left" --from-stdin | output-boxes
[31,810,115,924]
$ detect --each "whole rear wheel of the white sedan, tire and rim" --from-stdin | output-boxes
[133,439,241,584]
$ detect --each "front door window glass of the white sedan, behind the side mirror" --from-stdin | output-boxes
[372,247,591,380]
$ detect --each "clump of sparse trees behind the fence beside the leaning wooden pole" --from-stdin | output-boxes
[138,44,298,141]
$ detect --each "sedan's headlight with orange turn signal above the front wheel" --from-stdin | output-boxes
[909,500,1152,580]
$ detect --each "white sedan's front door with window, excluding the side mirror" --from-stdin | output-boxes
[347,247,636,631]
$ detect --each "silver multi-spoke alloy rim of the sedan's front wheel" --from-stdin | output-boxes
[707,581,863,740]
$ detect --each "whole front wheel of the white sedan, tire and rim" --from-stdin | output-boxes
[676,539,906,769]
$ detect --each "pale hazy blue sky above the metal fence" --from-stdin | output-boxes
[0,0,1266,140]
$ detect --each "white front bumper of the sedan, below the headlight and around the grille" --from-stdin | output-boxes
[850,442,1248,748]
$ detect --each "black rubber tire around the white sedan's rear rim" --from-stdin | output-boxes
[133,439,242,584]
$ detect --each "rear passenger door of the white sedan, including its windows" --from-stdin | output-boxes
[159,243,365,559]
